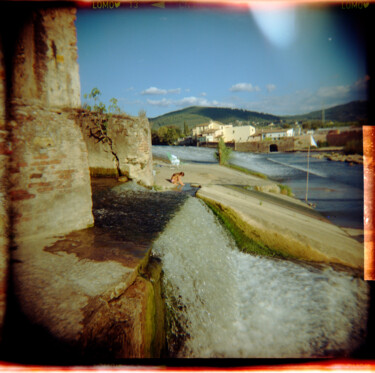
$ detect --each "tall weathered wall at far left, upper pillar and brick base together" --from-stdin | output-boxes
[0,2,93,346]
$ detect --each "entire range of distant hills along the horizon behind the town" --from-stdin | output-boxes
[149,101,368,129]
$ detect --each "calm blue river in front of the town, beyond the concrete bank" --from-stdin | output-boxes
[152,145,363,229]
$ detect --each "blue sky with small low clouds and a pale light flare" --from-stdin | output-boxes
[76,2,372,118]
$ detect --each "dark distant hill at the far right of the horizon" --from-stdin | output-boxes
[283,101,368,122]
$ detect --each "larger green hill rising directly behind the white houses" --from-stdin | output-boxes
[149,106,280,129]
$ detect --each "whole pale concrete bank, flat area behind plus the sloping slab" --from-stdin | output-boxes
[154,159,363,268]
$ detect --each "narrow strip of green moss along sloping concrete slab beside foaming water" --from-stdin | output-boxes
[203,199,291,259]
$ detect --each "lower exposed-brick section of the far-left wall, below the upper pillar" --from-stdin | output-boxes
[9,106,93,241]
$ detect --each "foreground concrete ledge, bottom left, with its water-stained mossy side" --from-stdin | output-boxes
[6,228,164,364]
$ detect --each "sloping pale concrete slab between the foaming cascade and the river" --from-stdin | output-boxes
[197,185,364,268]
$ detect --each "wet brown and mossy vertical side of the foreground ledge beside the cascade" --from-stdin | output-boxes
[81,259,166,361]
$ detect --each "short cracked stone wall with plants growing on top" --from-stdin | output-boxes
[75,110,154,186]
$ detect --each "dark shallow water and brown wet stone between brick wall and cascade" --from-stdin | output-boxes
[44,179,190,268]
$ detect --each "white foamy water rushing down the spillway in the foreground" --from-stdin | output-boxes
[153,198,368,358]
